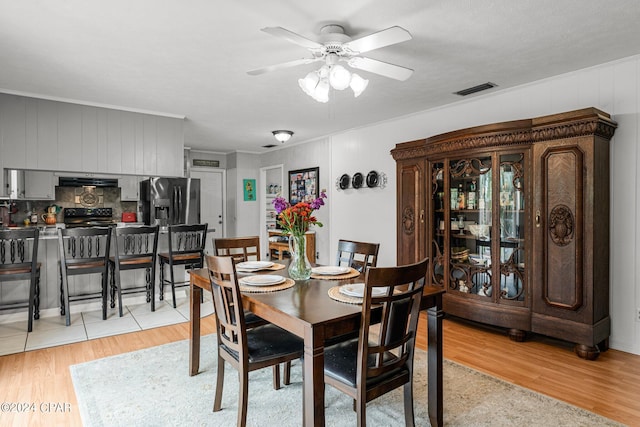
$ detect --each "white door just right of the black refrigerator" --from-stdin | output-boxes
[190,167,226,255]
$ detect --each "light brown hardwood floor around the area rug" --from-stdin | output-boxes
[0,316,640,426]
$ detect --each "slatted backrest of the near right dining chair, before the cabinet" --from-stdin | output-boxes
[357,259,428,381]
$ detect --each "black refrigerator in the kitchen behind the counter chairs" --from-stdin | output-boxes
[140,178,200,227]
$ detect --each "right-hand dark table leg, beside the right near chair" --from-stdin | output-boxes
[427,295,444,427]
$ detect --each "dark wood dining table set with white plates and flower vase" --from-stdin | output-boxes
[189,260,444,426]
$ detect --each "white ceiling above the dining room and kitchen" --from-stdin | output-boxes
[0,0,640,153]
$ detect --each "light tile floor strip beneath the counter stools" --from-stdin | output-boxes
[0,291,213,356]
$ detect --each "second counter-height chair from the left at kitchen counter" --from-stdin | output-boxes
[58,227,111,326]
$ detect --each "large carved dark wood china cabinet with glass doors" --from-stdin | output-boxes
[391,108,616,360]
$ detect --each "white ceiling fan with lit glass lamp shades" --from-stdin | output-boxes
[247,24,413,102]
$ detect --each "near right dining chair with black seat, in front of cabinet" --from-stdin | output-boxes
[324,259,428,426]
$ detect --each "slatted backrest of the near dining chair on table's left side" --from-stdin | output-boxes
[206,255,247,360]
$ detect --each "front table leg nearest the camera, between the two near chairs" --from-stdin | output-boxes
[302,329,324,426]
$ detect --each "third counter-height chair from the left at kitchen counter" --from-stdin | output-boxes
[109,225,160,317]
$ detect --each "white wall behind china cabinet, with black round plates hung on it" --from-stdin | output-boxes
[261,56,640,354]
